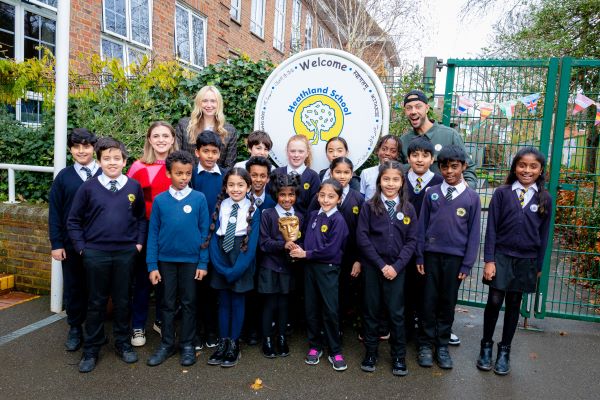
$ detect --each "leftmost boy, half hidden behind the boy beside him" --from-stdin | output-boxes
[48,128,102,351]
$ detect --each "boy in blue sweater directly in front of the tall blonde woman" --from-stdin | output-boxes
[192,130,226,351]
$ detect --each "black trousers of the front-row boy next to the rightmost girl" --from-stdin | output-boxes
[419,252,463,348]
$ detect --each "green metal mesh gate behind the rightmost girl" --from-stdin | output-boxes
[443,58,600,321]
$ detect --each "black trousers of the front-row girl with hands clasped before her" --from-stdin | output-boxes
[363,264,406,357]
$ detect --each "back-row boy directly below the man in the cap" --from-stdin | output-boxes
[404,137,444,339]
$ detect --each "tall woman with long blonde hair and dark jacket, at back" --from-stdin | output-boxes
[175,86,238,169]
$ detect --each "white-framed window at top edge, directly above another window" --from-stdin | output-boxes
[104,0,152,48]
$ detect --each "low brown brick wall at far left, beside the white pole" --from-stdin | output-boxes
[0,203,52,294]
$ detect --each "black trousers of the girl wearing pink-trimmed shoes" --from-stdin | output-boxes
[304,261,342,354]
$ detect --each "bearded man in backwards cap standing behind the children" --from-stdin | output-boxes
[400,90,477,189]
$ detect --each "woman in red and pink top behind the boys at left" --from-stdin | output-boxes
[127,121,177,346]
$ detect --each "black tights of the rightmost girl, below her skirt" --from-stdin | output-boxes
[483,287,523,345]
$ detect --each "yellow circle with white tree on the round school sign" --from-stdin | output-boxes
[294,95,344,145]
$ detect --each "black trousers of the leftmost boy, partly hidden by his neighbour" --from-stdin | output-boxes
[61,249,87,327]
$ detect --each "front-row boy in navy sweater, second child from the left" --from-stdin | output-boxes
[67,138,146,372]
